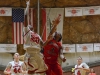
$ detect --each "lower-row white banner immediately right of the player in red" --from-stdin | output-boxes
[63,44,75,53]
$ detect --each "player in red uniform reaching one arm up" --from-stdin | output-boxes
[43,15,66,75]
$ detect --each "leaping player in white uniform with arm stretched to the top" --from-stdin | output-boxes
[23,1,47,74]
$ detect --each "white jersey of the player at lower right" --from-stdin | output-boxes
[75,63,89,75]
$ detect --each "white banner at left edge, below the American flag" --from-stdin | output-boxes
[0,44,17,53]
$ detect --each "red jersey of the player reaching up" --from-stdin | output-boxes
[43,39,61,64]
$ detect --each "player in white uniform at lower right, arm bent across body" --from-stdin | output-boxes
[75,57,90,75]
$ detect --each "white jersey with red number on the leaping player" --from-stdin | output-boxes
[24,26,41,47]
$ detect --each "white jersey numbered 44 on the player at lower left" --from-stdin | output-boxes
[9,61,23,75]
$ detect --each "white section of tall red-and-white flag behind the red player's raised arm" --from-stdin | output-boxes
[46,8,64,42]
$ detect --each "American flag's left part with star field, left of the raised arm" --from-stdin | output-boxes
[12,8,24,44]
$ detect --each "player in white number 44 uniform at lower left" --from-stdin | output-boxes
[4,53,26,75]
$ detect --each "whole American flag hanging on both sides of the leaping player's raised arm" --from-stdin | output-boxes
[12,8,35,44]
